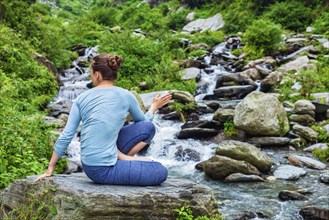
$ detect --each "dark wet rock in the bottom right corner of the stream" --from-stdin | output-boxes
[299,206,329,220]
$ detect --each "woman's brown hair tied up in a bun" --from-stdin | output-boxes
[91,54,122,80]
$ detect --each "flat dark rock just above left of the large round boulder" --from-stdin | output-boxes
[214,85,255,97]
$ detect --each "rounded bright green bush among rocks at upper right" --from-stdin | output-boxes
[243,19,283,59]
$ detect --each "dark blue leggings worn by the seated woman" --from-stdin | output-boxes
[83,121,168,186]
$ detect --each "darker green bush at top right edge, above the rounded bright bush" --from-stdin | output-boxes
[264,1,314,31]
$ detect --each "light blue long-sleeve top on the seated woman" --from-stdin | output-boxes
[54,87,153,166]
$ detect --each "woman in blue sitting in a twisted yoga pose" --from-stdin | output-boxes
[35,54,171,186]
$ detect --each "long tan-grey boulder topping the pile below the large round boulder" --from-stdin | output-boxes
[216,140,272,172]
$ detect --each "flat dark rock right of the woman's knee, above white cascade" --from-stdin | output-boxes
[177,128,218,139]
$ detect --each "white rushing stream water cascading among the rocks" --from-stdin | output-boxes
[55,45,329,220]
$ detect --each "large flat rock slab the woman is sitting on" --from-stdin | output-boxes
[0,173,218,219]
